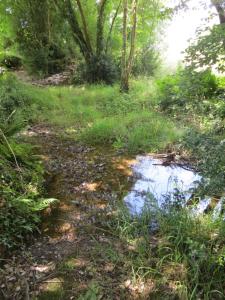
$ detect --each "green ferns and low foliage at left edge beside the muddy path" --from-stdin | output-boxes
[0,136,55,249]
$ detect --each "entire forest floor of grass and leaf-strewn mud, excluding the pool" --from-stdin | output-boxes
[0,75,225,300]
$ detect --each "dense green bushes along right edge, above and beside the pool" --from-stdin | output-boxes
[157,68,225,195]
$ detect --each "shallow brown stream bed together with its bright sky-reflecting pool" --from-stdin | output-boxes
[0,124,223,299]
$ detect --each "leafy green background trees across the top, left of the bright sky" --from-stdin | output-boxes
[0,0,167,84]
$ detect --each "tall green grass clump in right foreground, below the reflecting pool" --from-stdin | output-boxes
[109,200,225,300]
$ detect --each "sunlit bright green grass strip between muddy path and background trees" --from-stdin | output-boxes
[6,75,179,153]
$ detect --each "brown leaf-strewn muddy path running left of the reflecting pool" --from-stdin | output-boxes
[1,125,144,300]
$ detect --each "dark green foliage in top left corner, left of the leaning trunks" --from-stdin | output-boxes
[2,0,74,76]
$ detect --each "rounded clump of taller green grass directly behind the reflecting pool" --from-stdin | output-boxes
[81,110,179,152]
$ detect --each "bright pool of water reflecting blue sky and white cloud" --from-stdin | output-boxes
[124,156,221,215]
